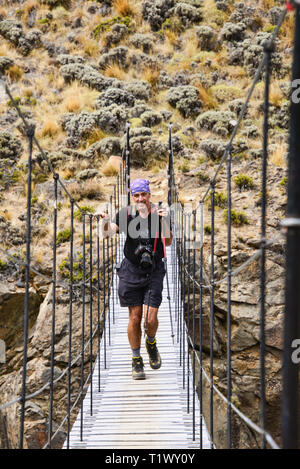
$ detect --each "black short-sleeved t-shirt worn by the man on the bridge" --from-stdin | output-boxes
[114,206,171,265]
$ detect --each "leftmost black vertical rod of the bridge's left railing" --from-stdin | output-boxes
[19,126,34,449]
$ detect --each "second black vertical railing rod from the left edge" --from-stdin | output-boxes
[48,174,58,449]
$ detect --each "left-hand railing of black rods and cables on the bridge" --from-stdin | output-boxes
[0,85,130,449]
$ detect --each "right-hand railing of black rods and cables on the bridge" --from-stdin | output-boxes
[168,3,287,449]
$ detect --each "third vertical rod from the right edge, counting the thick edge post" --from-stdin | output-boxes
[227,149,232,449]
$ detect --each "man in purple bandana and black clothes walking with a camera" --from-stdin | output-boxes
[96,179,172,379]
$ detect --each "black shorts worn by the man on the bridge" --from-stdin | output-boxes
[118,257,166,308]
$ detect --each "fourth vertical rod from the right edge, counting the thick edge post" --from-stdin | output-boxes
[209,183,215,449]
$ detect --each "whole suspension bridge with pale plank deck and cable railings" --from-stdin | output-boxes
[0,0,300,449]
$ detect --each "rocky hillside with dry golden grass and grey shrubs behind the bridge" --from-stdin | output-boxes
[0,0,293,447]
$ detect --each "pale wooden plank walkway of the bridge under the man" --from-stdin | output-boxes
[64,243,210,449]
